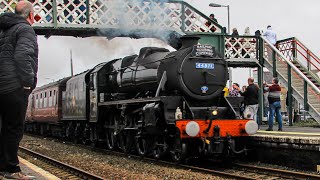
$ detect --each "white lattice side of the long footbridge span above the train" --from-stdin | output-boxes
[0,0,222,33]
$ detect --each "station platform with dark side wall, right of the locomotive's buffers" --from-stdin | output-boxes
[249,124,320,172]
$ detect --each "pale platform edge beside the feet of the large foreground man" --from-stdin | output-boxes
[19,157,59,180]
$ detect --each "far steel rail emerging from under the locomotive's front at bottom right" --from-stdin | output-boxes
[233,163,320,179]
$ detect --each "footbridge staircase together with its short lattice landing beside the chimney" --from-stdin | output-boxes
[225,35,320,123]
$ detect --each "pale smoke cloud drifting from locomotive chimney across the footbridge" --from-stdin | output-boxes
[94,0,180,44]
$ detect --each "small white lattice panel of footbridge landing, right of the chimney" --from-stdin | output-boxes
[225,36,257,59]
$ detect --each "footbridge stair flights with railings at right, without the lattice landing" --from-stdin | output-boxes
[260,37,320,123]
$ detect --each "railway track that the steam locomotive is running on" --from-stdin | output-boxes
[20,136,320,180]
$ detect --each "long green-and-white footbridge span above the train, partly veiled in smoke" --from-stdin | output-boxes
[0,0,225,47]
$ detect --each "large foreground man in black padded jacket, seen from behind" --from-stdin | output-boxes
[0,1,38,179]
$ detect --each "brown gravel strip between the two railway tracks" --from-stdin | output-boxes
[20,135,223,180]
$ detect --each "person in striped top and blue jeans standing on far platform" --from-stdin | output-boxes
[265,78,282,131]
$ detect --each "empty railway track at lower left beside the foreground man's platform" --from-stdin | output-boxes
[19,146,103,180]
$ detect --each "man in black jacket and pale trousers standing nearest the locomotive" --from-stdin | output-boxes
[240,77,259,124]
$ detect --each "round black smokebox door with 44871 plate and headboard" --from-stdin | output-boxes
[179,44,227,99]
